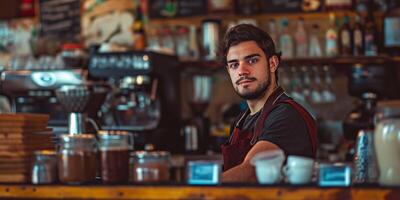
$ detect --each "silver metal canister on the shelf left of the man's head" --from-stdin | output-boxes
[202,19,220,60]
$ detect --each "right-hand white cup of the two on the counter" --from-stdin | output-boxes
[283,155,314,184]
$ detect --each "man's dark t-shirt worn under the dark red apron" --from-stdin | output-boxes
[234,94,313,157]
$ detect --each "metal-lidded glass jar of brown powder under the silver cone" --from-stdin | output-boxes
[58,134,97,184]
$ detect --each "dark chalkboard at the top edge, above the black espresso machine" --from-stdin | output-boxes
[149,0,207,18]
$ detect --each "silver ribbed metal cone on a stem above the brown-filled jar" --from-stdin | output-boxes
[55,84,109,135]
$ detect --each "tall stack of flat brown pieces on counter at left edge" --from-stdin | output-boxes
[0,114,55,183]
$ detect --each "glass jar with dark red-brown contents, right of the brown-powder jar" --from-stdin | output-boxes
[98,131,133,184]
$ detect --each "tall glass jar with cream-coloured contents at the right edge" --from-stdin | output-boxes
[374,100,400,186]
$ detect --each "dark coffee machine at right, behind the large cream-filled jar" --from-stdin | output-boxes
[343,63,398,161]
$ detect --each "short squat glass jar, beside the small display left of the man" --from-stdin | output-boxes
[131,151,171,182]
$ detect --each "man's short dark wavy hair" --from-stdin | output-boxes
[219,24,281,82]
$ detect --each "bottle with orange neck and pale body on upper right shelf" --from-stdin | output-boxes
[325,13,339,57]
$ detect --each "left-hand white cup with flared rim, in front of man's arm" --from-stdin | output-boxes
[251,150,285,184]
